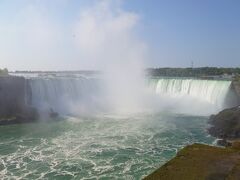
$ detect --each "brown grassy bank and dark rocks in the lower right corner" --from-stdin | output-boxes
[145,106,240,180]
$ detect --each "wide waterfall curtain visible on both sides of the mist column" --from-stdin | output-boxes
[22,75,231,114]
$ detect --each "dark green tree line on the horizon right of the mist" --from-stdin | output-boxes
[147,67,240,77]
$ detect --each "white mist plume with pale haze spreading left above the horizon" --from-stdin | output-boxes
[0,0,150,111]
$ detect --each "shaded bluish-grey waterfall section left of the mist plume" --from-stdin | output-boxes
[28,77,100,113]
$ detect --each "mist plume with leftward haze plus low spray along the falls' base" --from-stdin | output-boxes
[0,0,234,114]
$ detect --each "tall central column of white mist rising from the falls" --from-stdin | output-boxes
[74,0,146,112]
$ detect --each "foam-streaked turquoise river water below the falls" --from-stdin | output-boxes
[0,113,214,180]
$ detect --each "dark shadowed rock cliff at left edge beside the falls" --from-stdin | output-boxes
[0,76,38,125]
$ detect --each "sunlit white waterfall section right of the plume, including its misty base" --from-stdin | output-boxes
[149,78,231,114]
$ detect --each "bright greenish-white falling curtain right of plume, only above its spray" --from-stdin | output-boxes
[150,78,231,109]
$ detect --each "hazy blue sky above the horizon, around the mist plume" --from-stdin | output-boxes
[0,0,240,70]
